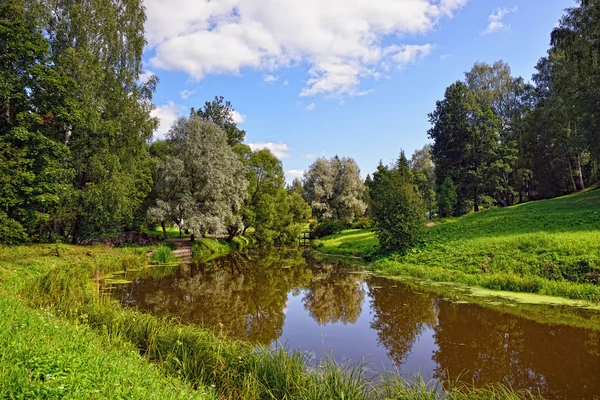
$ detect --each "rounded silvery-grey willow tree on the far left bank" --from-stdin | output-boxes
[150,116,248,239]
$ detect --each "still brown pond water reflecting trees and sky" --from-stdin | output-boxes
[104,251,600,399]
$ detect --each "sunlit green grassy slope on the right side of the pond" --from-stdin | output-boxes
[316,189,600,302]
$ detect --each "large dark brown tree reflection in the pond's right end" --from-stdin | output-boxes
[433,302,600,399]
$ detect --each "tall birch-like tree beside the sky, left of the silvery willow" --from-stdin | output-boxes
[40,0,156,242]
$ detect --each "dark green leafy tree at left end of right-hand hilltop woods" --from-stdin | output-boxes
[428,81,499,215]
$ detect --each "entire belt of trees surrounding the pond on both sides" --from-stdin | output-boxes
[0,0,600,249]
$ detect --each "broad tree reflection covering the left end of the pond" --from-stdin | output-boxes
[115,251,312,344]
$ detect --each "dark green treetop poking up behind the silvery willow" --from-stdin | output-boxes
[190,96,246,147]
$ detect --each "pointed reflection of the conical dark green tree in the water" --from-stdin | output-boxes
[369,278,436,366]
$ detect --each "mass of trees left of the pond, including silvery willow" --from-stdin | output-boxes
[0,0,310,244]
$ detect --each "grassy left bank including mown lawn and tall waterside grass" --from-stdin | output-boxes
[0,245,540,399]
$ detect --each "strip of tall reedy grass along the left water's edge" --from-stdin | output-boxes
[21,265,540,399]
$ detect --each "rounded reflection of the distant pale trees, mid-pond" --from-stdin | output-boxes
[302,264,365,325]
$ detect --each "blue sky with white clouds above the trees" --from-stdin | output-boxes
[144,0,575,182]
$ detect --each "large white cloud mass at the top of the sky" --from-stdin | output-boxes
[145,0,467,96]
